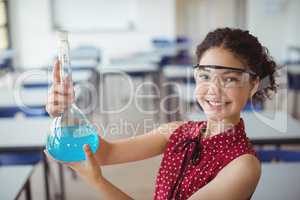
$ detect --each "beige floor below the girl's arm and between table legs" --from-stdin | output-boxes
[25,156,161,200]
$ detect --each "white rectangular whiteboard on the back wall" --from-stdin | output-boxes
[51,0,137,32]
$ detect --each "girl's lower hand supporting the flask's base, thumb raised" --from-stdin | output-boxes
[45,144,103,187]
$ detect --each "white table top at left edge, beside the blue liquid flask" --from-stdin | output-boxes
[0,117,52,149]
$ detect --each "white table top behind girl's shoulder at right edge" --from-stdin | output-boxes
[187,111,300,140]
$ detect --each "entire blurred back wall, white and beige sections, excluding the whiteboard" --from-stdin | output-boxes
[9,0,300,67]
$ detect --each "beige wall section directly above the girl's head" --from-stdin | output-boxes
[176,0,237,52]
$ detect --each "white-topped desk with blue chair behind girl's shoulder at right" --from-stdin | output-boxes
[187,111,300,162]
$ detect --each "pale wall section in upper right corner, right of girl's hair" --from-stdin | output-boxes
[247,0,300,62]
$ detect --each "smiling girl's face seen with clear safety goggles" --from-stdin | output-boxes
[194,48,254,122]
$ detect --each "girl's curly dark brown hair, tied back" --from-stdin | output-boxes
[196,27,278,104]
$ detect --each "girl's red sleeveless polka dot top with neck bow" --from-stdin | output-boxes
[154,119,256,200]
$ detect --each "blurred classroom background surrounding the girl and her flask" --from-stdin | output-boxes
[0,0,300,200]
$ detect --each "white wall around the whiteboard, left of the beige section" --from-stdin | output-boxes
[9,0,176,67]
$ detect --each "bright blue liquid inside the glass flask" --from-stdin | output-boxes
[46,125,99,162]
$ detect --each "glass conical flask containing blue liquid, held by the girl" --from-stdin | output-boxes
[46,31,99,162]
